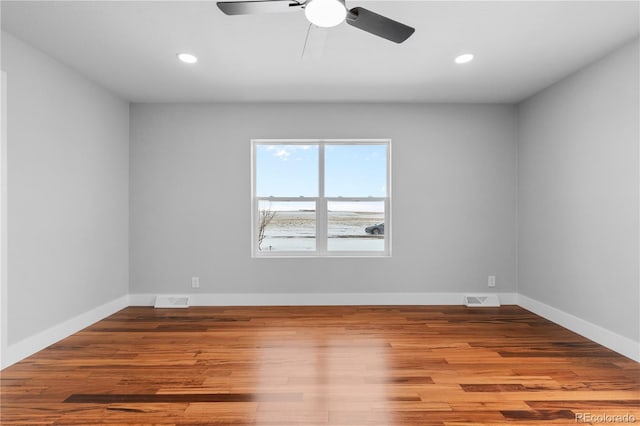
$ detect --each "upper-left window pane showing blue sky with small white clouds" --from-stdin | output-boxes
[256,144,318,197]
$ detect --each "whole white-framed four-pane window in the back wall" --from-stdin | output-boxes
[252,139,391,257]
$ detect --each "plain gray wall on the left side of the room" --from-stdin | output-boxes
[2,33,129,344]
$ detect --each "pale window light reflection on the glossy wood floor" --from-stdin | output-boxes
[252,329,391,425]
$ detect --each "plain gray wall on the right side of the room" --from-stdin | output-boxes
[518,40,640,341]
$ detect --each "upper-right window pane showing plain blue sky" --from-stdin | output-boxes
[325,145,387,197]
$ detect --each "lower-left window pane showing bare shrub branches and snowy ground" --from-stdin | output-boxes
[257,200,316,252]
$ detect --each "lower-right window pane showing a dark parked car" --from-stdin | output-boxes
[327,201,385,251]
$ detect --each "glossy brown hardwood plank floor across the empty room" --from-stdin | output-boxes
[0,306,640,426]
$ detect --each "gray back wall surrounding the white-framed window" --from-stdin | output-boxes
[130,104,517,294]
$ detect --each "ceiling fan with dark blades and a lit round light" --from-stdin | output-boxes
[217,0,415,43]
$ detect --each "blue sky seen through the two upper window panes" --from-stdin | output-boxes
[256,144,387,197]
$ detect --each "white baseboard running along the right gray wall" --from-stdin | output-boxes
[518,294,640,362]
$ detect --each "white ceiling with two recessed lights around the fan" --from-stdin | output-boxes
[1,0,640,103]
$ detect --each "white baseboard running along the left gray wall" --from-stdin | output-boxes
[2,295,129,368]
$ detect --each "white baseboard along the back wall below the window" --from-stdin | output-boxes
[129,293,518,306]
